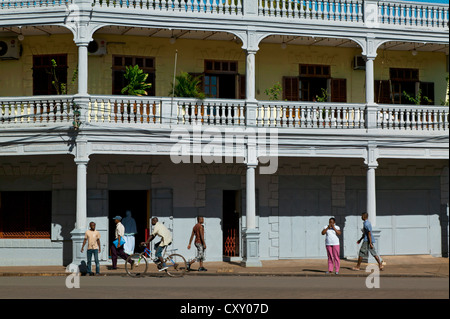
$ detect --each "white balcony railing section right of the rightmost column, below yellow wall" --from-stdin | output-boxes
[377,105,449,131]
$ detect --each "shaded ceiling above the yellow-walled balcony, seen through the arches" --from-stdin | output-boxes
[0,26,449,54]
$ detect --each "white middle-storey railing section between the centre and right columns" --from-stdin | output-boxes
[257,102,365,128]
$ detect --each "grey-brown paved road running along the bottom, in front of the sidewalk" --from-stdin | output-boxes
[0,276,449,300]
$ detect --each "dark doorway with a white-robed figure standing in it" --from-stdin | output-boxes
[109,190,150,251]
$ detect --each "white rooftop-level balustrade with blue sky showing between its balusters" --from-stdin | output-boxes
[0,0,449,29]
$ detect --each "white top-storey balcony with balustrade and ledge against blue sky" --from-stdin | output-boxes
[0,0,449,36]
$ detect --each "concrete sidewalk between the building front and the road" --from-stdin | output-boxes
[0,255,449,278]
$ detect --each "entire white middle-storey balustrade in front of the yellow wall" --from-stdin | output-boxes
[0,95,449,131]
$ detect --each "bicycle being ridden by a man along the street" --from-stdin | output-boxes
[125,246,188,277]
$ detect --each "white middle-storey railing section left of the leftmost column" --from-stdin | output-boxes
[0,95,74,125]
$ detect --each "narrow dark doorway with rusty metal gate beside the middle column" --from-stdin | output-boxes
[222,190,241,259]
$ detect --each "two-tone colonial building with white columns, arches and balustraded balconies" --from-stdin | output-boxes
[0,0,449,266]
